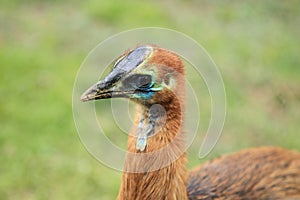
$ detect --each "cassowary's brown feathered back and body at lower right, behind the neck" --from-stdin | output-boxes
[187,147,300,200]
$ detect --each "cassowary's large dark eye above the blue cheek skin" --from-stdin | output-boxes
[123,74,152,89]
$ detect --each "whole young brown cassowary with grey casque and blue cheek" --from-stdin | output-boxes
[81,45,300,200]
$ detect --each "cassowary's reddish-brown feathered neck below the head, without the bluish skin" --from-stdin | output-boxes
[118,98,187,200]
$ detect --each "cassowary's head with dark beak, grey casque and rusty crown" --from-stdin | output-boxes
[81,45,184,106]
